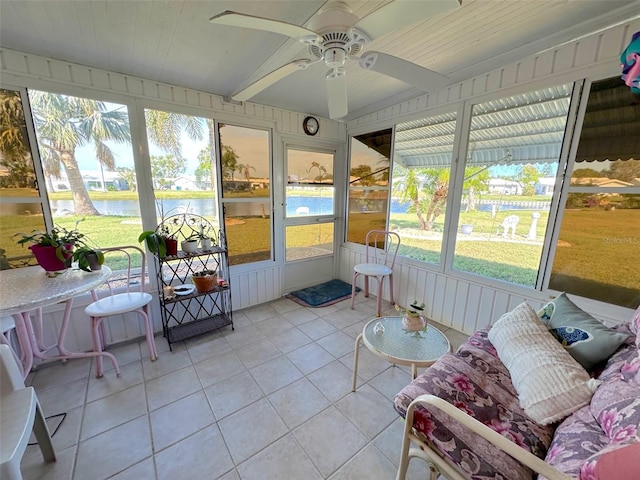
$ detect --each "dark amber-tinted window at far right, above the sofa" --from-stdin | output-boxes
[549,78,640,308]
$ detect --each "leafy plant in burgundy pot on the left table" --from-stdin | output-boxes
[14,219,85,273]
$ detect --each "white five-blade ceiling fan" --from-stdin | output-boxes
[210,0,460,119]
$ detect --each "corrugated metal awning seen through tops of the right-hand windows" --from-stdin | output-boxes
[394,78,640,168]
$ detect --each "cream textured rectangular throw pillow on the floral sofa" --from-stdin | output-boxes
[488,303,600,425]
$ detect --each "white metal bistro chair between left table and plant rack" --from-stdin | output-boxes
[84,245,158,378]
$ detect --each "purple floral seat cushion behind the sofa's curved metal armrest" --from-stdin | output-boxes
[394,330,553,480]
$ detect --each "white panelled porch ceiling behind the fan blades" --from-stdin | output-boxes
[0,0,640,119]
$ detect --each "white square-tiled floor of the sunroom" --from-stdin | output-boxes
[22,295,466,480]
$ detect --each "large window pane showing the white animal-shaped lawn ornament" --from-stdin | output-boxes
[453,84,572,287]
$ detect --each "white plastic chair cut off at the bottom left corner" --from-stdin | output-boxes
[0,344,56,480]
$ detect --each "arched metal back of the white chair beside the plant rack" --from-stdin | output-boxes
[91,245,147,300]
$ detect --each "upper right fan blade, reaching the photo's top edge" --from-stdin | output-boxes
[354,0,461,39]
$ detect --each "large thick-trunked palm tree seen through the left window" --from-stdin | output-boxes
[30,91,131,215]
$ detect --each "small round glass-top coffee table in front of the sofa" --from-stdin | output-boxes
[351,317,451,392]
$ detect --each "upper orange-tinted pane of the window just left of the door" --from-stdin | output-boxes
[220,124,271,198]
